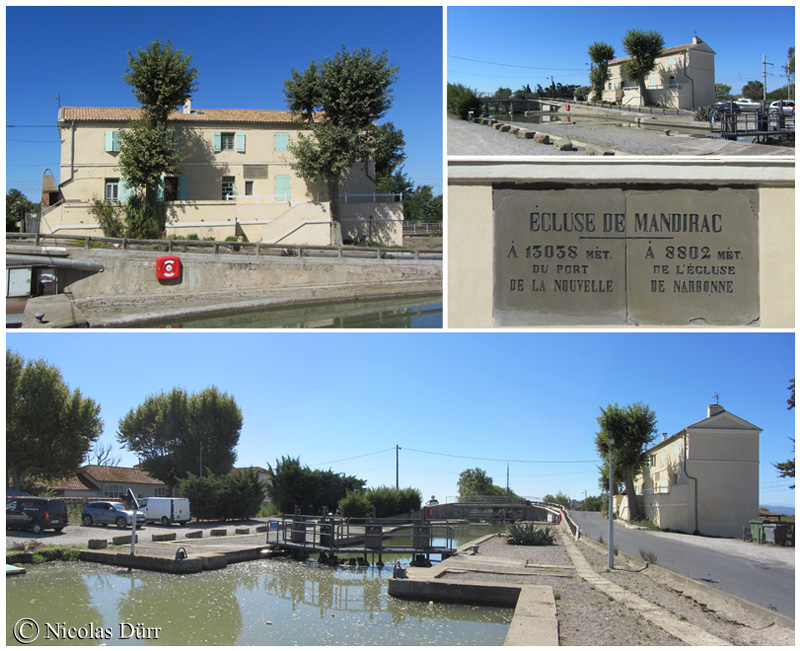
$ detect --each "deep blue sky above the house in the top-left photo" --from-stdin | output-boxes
[6,6,444,202]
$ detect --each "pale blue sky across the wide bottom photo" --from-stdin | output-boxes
[6,331,795,505]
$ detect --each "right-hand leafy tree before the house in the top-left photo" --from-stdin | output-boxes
[283,47,399,244]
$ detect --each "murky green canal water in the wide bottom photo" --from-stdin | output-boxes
[6,528,506,646]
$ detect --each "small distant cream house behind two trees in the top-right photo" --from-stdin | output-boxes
[602,36,715,109]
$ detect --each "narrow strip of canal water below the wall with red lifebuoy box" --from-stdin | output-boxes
[131,294,443,328]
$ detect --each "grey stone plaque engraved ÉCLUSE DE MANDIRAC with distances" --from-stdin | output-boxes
[493,184,759,326]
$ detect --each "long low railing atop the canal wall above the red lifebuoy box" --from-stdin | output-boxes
[6,233,442,260]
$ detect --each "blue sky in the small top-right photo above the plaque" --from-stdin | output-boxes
[447,2,795,94]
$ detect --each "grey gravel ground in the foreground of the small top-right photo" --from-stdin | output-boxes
[447,116,794,156]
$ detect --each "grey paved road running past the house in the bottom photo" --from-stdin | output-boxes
[570,511,795,617]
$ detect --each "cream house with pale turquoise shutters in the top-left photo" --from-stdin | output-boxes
[41,101,403,245]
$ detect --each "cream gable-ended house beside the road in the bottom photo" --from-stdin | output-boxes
[616,405,761,537]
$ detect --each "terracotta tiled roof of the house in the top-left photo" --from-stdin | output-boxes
[58,106,310,123]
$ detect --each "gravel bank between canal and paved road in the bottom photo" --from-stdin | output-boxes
[447,530,794,646]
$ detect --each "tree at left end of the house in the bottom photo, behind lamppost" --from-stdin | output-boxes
[595,402,656,520]
